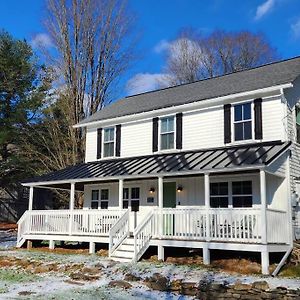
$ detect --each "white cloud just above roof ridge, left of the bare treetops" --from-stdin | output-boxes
[126,73,166,95]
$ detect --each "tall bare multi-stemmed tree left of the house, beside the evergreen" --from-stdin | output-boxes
[46,0,135,161]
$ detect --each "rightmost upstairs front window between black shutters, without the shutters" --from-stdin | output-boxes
[233,102,252,141]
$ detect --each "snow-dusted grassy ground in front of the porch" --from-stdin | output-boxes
[0,231,300,300]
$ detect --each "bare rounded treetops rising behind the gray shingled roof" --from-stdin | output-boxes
[164,30,277,85]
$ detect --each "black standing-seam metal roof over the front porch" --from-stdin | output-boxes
[23,141,290,187]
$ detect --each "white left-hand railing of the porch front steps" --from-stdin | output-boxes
[108,209,129,257]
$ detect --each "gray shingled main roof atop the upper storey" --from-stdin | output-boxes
[79,57,300,124]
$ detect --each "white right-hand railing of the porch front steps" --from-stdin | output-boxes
[133,211,154,262]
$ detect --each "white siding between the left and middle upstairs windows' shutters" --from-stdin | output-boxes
[121,120,152,157]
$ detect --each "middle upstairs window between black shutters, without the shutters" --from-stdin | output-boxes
[160,116,175,150]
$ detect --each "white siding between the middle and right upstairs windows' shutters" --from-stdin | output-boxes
[182,106,224,150]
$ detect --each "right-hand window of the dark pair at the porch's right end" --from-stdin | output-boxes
[232,181,252,207]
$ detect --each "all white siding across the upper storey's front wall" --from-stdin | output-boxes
[86,96,286,162]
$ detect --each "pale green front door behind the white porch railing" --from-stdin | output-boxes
[163,182,176,235]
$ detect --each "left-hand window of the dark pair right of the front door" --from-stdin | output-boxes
[210,182,229,208]
